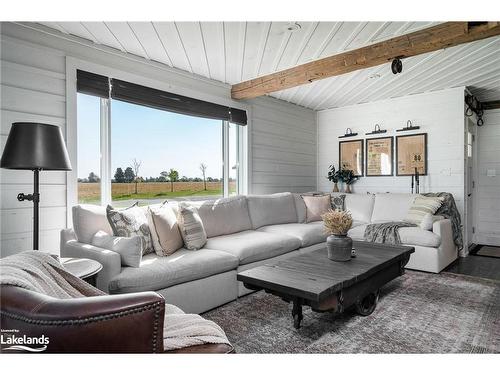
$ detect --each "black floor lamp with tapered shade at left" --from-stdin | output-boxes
[0,122,71,250]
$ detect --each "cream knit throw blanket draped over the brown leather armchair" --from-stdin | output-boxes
[0,251,230,350]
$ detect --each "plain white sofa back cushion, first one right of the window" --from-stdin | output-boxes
[247,193,297,229]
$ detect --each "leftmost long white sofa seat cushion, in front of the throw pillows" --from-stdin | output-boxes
[109,248,238,293]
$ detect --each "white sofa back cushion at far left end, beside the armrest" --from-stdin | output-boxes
[72,204,113,244]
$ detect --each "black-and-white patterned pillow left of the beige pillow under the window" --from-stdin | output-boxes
[106,203,154,254]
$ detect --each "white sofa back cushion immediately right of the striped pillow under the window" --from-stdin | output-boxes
[197,195,252,238]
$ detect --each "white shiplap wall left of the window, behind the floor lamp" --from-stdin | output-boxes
[0,35,66,256]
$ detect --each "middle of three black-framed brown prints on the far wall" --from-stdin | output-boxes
[365,137,394,177]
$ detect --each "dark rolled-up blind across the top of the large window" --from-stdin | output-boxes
[77,70,247,125]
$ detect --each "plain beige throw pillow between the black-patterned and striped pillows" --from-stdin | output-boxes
[148,202,184,256]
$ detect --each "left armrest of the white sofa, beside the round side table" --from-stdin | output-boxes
[61,229,122,293]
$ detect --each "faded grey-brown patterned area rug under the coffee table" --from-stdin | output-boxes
[203,271,500,353]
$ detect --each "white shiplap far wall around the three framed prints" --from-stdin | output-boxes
[317,87,464,219]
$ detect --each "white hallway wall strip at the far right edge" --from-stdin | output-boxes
[475,109,500,246]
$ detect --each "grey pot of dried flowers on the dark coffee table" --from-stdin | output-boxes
[321,210,352,262]
